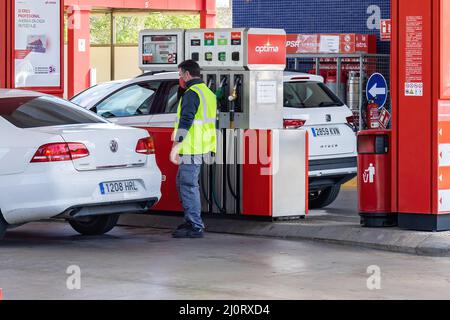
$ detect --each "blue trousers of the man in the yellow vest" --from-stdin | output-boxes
[177,163,205,230]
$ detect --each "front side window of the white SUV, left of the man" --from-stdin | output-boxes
[94,81,161,118]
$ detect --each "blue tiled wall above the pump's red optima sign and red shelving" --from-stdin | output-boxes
[233,0,390,53]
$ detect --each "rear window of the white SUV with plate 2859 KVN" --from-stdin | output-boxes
[284,81,344,108]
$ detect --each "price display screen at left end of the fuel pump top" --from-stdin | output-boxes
[142,35,178,65]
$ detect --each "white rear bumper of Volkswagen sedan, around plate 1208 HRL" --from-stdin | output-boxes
[0,160,162,224]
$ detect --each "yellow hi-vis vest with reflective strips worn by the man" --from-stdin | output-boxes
[175,83,217,155]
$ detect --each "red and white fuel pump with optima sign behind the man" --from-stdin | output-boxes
[140,29,308,218]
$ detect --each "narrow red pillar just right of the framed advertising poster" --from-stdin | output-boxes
[67,6,90,98]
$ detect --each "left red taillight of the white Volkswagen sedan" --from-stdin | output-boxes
[31,142,89,163]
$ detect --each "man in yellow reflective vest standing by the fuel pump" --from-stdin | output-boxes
[170,60,217,238]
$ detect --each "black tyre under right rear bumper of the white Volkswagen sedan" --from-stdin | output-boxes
[69,214,119,236]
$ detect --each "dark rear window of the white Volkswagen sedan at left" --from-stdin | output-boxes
[0,96,106,128]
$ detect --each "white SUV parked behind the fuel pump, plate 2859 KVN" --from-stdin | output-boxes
[71,72,357,208]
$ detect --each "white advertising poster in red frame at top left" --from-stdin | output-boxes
[14,0,61,88]
